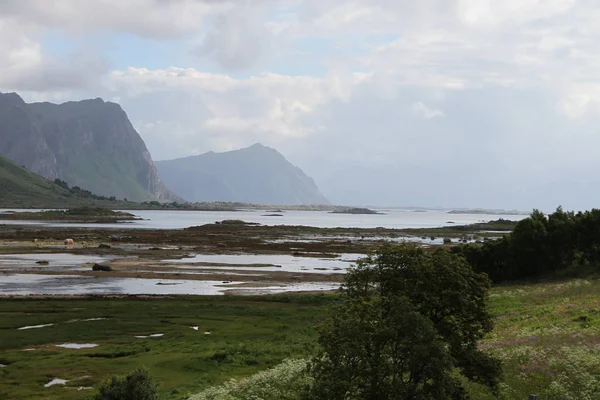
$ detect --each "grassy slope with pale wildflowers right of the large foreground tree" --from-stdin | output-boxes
[470,279,600,400]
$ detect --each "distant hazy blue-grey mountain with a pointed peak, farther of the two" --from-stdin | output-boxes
[156,144,329,205]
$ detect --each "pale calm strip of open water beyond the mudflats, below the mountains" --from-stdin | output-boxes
[0,210,525,229]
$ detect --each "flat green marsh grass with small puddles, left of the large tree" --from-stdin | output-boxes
[0,295,332,399]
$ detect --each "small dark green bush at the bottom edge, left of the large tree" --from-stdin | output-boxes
[92,367,158,400]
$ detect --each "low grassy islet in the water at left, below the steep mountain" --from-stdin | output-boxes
[0,207,141,223]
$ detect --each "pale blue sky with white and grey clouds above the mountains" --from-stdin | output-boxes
[0,0,600,211]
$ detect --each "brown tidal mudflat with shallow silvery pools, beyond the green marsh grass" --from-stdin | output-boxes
[0,220,510,296]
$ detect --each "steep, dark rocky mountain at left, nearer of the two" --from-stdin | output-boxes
[0,93,177,201]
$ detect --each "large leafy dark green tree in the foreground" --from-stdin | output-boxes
[309,245,500,400]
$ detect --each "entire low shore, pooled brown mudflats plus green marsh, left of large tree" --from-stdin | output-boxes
[0,221,536,399]
